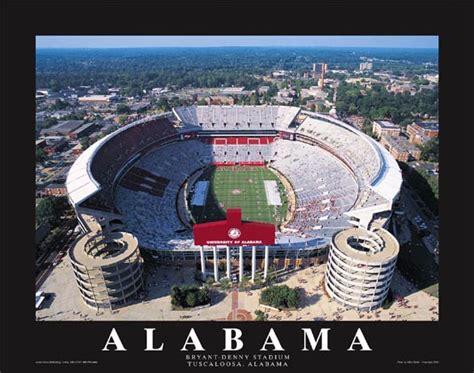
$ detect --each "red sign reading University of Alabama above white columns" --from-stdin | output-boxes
[193,209,275,246]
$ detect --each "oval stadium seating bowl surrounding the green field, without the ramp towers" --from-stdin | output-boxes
[66,105,402,290]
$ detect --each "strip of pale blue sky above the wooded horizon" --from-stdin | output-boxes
[36,35,438,48]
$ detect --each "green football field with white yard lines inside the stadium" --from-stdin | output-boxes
[189,166,288,225]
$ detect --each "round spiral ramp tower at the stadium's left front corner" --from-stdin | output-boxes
[69,232,143,309]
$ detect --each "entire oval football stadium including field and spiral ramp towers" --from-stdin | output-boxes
[66,105,402,309]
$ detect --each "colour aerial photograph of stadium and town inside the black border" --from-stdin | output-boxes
[34,35,439,325]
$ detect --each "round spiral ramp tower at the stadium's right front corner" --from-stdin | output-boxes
[324,228,399,311]
